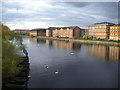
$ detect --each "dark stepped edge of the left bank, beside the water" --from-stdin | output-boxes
[2,49,30,90]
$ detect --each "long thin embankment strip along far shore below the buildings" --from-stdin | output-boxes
[36,36,120,46]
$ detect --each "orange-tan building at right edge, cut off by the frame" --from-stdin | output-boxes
[109,24,120,41]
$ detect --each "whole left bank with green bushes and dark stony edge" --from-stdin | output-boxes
[0,24,29,90]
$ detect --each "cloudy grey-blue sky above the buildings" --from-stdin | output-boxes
[2,0,118,30]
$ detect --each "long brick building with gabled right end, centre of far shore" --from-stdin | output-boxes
[46,26,81,38]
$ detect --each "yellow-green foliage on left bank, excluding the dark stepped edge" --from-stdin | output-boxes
[0,24,22,83]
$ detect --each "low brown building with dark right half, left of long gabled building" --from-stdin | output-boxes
[29,28,46,36]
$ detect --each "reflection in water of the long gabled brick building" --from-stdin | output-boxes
[46,40,81,51]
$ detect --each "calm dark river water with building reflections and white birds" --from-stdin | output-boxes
[23,38,120,88]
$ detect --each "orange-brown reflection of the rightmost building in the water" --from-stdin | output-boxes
[109,46,120,61]
